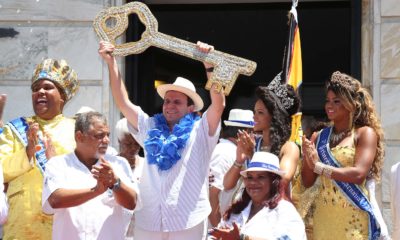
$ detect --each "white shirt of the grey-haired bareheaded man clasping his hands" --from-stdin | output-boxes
[42,153,139,240]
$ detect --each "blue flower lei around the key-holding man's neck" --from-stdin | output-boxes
[144,113,200,171]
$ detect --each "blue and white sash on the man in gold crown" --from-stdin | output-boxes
[7,117,47,174]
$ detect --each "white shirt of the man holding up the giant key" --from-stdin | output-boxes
[128,109,220,232]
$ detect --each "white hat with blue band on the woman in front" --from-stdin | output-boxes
[240,152,285,177]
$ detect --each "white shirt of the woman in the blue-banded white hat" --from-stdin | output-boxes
[220,200,307,240]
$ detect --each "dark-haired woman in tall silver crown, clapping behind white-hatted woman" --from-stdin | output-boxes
[224,74,300,199]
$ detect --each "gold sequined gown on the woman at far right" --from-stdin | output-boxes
[313,146,368,240]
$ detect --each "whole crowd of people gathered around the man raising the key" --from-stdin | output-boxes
[0,39,400,240]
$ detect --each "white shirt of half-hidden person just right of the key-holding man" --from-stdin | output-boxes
[210,138,242,216]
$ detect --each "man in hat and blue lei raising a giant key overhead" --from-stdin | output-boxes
[99,42,225,240]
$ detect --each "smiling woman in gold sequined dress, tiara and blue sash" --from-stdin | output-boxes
[302,72,383,240]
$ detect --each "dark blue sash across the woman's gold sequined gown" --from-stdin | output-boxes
[317,127,381,240]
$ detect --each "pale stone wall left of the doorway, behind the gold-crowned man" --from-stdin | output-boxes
[0,0,123,146]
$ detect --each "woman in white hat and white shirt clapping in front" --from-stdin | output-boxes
[210,152,306,240]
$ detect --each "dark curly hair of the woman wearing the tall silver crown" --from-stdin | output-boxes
[256,84,300,156]
